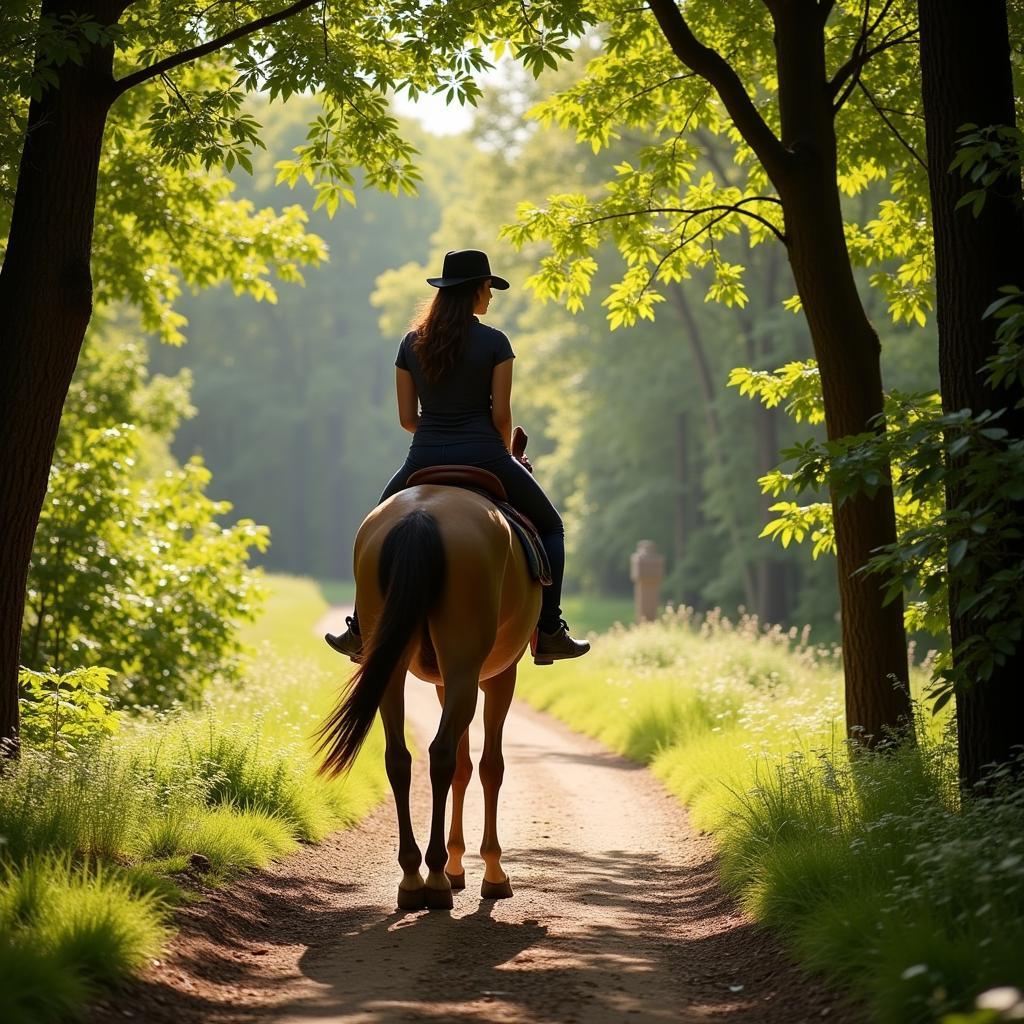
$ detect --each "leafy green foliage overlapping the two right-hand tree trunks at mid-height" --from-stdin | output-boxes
[729,119,1024,708]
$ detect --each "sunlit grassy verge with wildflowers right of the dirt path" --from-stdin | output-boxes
[520,615,1024,1024]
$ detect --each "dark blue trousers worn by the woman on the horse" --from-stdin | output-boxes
[381,441,565,633]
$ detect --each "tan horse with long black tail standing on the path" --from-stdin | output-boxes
[319,484,541,909]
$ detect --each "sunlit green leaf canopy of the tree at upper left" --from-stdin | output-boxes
[0,0,585,343]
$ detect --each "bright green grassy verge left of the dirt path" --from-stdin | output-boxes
[0,579,386,1024]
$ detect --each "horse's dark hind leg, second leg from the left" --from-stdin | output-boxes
[425,665,479,909]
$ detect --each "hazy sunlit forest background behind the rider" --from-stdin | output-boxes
[150,63,937,640]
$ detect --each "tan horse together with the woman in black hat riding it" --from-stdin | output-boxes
[319,250,590,909]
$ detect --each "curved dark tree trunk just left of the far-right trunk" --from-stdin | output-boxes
[774,4,911,743]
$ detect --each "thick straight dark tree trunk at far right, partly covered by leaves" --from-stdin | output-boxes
[919,0,1024,784]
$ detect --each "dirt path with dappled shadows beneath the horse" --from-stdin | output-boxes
[94,606,859,1024]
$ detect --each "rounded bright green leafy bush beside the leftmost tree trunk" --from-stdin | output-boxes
[23,331,268,708]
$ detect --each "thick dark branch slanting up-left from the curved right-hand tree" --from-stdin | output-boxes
[648,0,791,178]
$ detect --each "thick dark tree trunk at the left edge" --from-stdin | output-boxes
[0,0,118,739]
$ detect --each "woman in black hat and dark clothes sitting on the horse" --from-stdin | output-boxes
[326,249,590,665]
